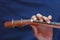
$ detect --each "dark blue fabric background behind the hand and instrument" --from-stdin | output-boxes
[0,0,60,40]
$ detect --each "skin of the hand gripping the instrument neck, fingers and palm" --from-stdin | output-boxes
[30,13,53,40]
